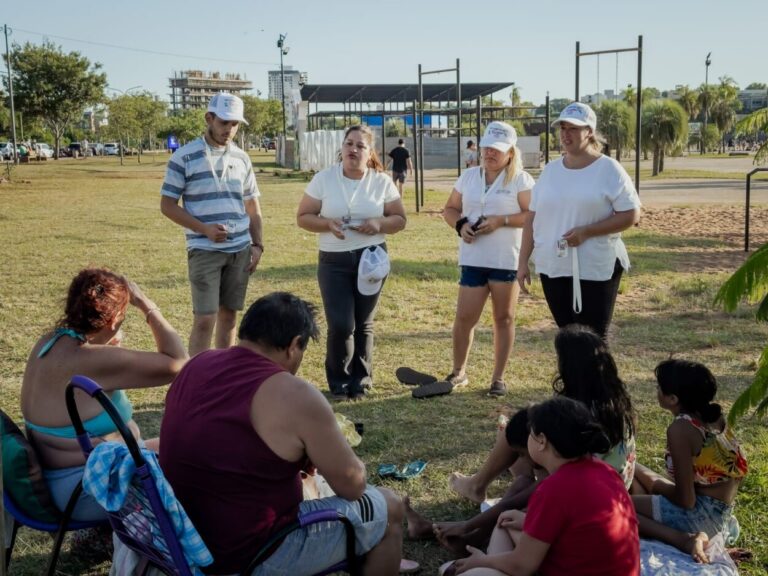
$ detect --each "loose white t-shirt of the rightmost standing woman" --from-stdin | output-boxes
[531,156,640,280]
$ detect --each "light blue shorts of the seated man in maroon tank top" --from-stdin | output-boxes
[251,486,387,576]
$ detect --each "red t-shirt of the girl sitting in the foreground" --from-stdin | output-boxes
[523,457,640,576]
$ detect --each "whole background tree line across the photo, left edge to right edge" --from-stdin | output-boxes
[0,41,768,166]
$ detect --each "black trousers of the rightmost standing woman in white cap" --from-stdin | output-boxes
[540,260,624,340]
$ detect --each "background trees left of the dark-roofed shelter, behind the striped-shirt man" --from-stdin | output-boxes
[0,41,282,157]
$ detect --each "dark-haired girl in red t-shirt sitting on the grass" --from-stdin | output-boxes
[443,397,640,576]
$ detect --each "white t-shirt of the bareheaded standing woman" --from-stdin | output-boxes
[306,163,400,252]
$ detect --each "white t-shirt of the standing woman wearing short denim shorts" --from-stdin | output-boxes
[453,166,535,270]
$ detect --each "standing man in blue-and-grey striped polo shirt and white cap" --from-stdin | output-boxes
[160,92,264,356]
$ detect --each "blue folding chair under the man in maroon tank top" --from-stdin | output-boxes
[66,376,362,576]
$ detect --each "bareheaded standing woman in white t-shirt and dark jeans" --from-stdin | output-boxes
[296,126,405,398]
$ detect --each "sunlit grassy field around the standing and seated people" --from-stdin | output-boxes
[0,155,768,576]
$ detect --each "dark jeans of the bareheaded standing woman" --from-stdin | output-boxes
[317,244,387,395]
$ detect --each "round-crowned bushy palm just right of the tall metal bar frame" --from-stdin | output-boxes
[642,100,688,176]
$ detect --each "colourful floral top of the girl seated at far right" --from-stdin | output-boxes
[664,414,747,486]
